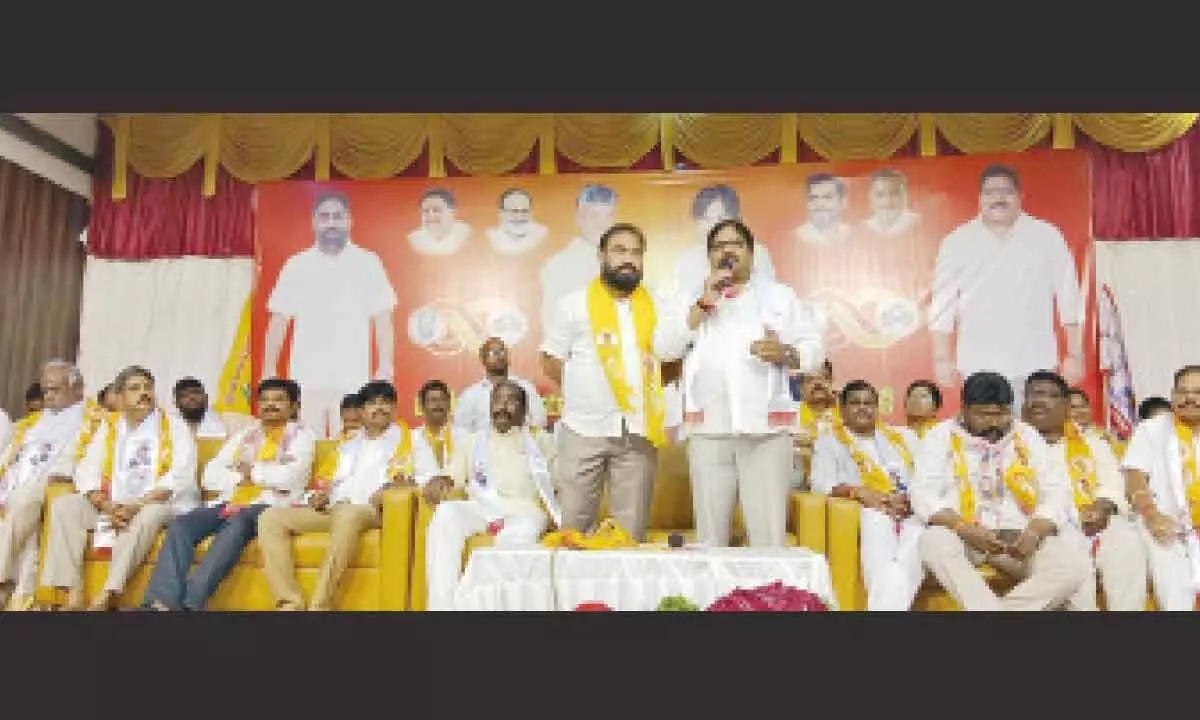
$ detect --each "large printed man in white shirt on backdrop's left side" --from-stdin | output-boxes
[263,192,396,438]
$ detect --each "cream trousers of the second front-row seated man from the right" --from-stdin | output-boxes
[1067,515,1147,612]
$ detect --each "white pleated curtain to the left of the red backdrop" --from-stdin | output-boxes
[79,257,254,407]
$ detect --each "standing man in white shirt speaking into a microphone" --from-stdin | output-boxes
[680,220,824,547]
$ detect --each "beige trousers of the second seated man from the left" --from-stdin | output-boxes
[42,493,172,593]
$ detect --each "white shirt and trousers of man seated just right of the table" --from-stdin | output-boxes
[812,428,925,611]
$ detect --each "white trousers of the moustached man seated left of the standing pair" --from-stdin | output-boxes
[425,500,546,611]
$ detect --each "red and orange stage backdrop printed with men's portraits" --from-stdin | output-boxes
[253,150,1099,429]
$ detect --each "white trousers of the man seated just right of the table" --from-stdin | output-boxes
[858,508,925,612]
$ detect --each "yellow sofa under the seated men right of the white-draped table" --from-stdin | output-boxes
[798,493,1157,611]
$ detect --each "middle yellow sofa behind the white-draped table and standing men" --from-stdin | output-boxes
[409,444,824,610]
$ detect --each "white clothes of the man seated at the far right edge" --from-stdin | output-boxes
[1121,413,1200,611]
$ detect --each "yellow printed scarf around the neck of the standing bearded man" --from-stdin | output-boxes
[588,277,667,448]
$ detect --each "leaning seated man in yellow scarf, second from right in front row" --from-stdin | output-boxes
[1021,370,1147,612]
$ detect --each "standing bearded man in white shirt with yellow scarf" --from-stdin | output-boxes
[541,223,688,541]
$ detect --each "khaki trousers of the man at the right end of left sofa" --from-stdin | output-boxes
[258,503,382,610]
